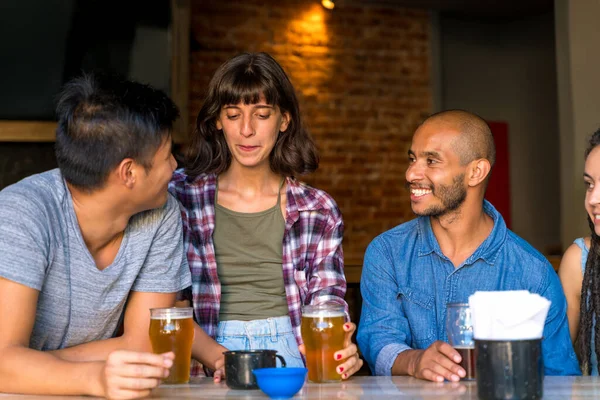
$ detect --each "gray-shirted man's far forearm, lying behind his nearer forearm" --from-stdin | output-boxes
[50,335,152,362]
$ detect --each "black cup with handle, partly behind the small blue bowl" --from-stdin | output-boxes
[223,350,286,389]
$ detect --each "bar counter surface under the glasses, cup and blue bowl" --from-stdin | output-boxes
[0,376,600,400]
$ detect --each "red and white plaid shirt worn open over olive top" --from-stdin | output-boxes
[169,169,348,375]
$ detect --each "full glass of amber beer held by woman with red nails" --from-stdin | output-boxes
[301,304,346,383]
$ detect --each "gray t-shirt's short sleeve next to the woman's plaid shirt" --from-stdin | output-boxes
[133,194,192,293]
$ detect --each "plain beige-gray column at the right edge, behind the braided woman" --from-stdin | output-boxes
[548,0,600,249]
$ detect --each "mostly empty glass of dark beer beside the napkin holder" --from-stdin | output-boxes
[446,303,475,380]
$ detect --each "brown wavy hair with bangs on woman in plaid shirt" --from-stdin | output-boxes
[183,53,319,177]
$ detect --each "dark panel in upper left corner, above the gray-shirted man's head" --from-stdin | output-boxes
[0,0,170,120]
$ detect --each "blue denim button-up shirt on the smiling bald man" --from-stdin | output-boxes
[357,201,581,375]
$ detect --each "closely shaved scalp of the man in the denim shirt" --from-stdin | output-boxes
[421,110,496,166]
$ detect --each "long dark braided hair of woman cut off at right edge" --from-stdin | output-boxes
[575,129,600,375]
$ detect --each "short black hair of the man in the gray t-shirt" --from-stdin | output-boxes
[55,73,179,191]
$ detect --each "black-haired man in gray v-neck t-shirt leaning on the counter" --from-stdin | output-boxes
[0,75,204,398]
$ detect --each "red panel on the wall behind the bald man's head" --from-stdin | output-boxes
[485,121,511,228]
